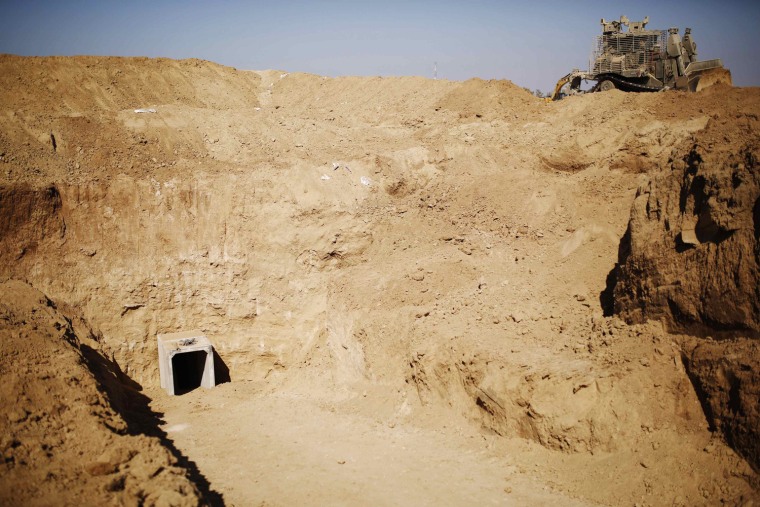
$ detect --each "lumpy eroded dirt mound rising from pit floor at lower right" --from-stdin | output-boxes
[409,321,701,453]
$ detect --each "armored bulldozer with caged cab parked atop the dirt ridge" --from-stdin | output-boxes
[551,16,731,100]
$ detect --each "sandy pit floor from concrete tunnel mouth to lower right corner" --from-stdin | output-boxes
[147,326,754,505]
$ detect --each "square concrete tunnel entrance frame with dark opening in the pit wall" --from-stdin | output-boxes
[157,330,216,396]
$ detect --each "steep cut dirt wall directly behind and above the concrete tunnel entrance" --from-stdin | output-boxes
[0,176,362,382]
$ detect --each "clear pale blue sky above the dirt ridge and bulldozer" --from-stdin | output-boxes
[0,0,760,91]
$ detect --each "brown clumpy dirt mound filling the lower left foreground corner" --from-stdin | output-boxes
[0,280,201,505]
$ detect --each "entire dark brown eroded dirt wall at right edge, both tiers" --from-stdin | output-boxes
[612,116,760,467]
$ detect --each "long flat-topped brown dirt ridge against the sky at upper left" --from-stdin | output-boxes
[0,55,258,115]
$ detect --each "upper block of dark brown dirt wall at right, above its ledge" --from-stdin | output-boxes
[615,133,760,335]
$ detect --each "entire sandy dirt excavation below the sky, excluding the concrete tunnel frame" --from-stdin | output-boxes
[0,56,760,505]
